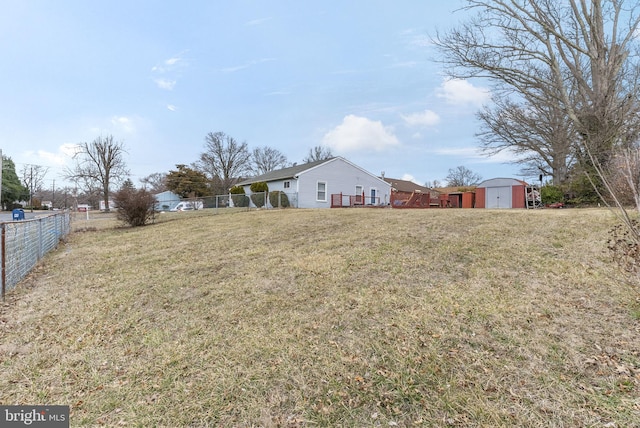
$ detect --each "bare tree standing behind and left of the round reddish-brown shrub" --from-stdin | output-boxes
[65,135,129,211]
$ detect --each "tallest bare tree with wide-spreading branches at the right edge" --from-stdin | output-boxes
[434,0,640,221]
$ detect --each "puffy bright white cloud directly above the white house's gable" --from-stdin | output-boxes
[322,115,400,152]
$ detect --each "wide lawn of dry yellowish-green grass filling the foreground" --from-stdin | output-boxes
[0,209,640,427]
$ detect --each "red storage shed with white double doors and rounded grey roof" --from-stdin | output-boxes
[476,178,528,209]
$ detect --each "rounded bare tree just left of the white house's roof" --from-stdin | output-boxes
[194,132,251,193]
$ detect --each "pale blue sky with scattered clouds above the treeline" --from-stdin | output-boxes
[0,0,526,191]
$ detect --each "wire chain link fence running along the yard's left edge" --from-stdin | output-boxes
[0,211,71,298]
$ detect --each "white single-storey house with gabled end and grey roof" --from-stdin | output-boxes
[238,156,391,208]
